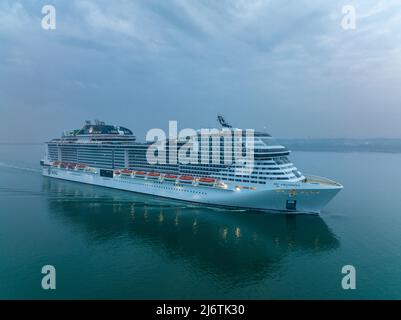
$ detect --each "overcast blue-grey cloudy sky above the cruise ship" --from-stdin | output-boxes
[0,0,401,142]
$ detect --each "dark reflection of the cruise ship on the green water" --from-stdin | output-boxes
[43,179,339,286]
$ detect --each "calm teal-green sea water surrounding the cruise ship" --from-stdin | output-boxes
[0,145,401,299]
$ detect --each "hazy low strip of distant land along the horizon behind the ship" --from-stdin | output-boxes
[0,138,401,153]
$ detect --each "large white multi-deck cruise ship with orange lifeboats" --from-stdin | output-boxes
[41,116,342,214]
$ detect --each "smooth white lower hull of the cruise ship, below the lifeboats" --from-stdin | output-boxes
[42,166,342,214]
